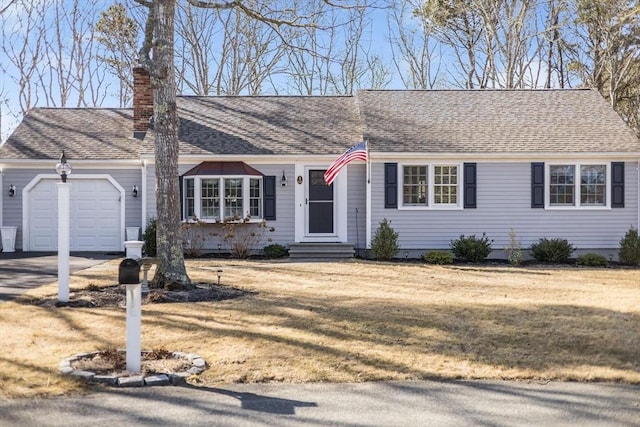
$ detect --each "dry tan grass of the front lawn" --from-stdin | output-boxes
[0,260,640,398]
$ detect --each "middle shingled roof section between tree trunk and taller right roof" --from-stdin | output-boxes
[170,96,362,155]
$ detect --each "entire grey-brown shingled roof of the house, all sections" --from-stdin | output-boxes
[0,90,640,160]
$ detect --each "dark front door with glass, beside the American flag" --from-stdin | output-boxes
[307,169,333,234]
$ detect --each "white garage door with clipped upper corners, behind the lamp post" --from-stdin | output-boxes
[29,179,122,251]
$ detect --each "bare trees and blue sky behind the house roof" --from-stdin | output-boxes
[0,0,640,136]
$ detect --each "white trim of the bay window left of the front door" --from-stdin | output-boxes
[182,175,264,224]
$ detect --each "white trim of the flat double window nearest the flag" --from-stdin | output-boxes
[398,162,464,211]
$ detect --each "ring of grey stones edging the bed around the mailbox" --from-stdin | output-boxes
[58,350,207,387]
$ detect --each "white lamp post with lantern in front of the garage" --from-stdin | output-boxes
[56,151,71,302]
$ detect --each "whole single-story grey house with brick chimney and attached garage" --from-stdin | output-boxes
[0,69,640,257]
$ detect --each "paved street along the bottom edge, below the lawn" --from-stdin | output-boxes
[0,381,640,427]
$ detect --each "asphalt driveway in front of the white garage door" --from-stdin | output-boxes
[0,252,120,303]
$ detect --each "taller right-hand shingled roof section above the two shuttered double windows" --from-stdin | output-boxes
[358,89,640,153]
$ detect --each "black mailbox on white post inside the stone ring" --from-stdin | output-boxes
[118,258,142,373]
